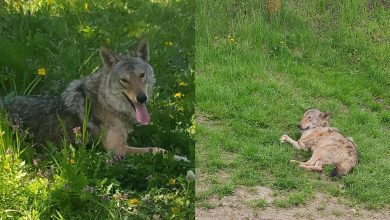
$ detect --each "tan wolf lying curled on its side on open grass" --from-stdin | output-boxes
[280,109,359,176]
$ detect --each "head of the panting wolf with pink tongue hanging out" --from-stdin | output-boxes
[100,40,155,125]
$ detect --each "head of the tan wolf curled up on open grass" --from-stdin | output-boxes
[298,109,330,131]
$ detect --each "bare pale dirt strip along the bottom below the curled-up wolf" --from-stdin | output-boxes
[196,186,390,220]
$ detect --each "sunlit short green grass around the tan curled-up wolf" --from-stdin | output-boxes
[195,0,390,208]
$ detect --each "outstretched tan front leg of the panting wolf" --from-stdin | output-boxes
[103,127,165,156]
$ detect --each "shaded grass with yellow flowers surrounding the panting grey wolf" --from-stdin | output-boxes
[0,0,195,219]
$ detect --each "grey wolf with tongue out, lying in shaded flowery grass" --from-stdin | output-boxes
[2,39,165,156]
